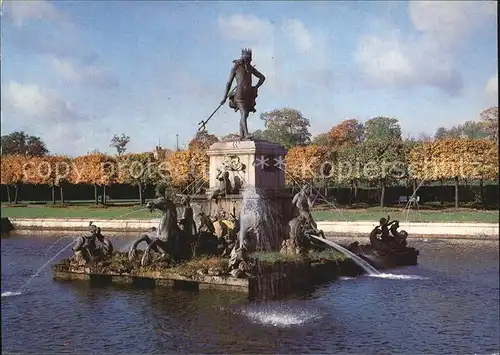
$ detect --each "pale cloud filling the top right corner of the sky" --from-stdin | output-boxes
[408,0,497,45]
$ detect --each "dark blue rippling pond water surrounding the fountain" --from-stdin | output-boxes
[1,236,500,354]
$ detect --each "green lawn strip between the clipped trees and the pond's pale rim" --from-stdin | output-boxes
[1,205,499,223]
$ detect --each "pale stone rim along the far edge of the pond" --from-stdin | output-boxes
[5,218,499,238]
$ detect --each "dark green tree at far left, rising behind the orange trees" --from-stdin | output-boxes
[1,132,49,157]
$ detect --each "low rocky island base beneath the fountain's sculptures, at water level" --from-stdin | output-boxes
[53,251,363,299]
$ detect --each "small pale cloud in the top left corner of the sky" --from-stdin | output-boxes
[5,0,64,27]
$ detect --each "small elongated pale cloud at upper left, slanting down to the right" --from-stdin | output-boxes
[50,56,117,87]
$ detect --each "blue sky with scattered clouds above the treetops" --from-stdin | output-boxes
[1,1,498,155]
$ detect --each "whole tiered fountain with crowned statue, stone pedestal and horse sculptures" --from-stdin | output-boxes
[49,50,418,299]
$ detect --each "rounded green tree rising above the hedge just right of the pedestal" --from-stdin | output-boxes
[260,108,311,149]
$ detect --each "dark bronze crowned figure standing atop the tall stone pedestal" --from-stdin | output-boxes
[221,49,266,140]
